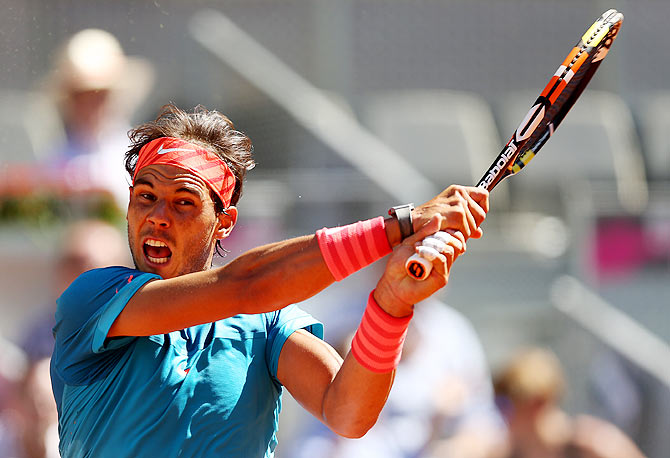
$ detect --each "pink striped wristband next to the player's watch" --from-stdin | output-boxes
[316,216,391,281]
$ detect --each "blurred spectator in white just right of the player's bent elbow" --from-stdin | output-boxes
[281,299,505,458]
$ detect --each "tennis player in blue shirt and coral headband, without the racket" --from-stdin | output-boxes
[51,105,488,458]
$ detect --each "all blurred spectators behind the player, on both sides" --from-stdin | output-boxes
[0,29,660,458]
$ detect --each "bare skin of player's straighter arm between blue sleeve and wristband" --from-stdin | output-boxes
[107,236,334,337]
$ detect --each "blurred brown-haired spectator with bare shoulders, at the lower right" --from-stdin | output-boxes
[494,348,643,458]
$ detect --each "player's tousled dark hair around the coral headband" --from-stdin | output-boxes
[125,103,255,252]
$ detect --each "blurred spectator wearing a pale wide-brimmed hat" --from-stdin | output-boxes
[40,29,153,210]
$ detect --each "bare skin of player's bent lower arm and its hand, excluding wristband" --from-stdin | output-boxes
[277,218,465,438]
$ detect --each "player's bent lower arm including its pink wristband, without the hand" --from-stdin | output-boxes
[277,288,411,438]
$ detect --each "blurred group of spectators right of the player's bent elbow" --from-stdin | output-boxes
[277,284,645,458]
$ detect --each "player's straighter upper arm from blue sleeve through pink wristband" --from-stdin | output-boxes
[113,218,399,337]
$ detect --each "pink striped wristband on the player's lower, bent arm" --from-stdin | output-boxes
[351,290,413,373]
